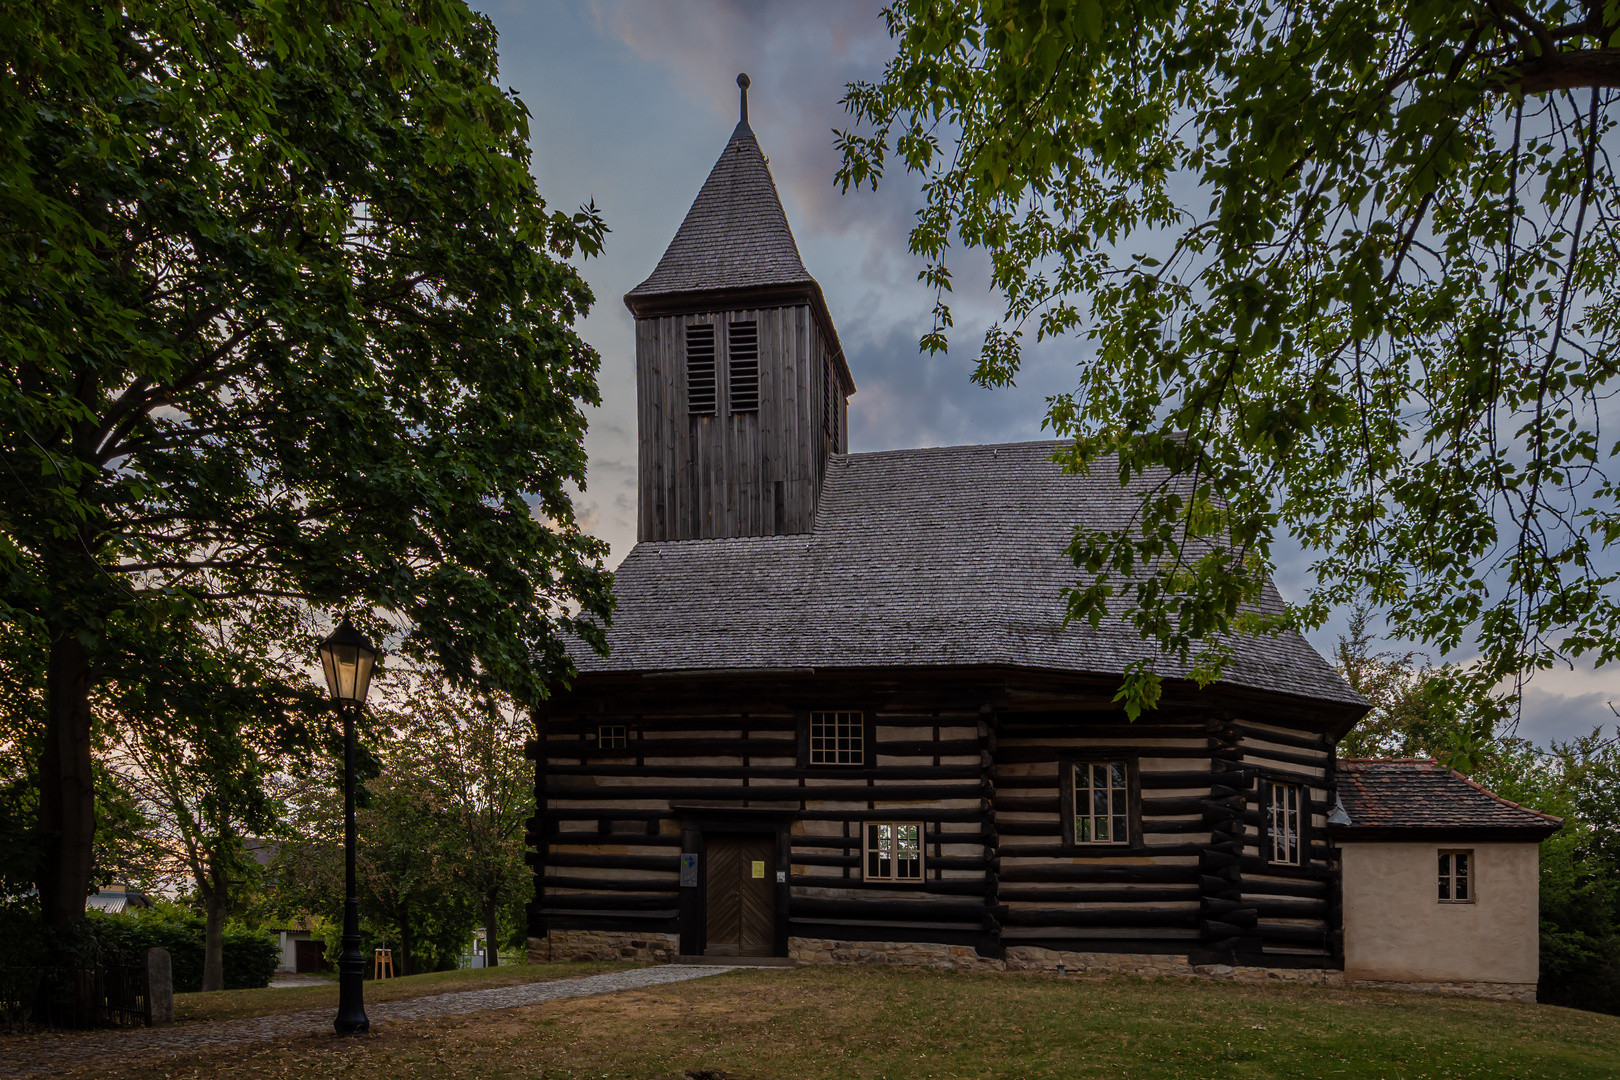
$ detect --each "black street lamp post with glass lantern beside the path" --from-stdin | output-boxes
[321,615,377,1035]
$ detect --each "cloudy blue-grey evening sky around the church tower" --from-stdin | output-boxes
[483,0,1620,740]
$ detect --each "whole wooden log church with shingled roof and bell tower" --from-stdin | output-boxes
[528,76,1561,990]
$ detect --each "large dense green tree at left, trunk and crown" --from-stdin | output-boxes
[0,0,611,928]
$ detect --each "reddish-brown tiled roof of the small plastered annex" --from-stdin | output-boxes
[1333,758,1563,840]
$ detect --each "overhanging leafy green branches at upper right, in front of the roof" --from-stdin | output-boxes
[839,0,1620,714]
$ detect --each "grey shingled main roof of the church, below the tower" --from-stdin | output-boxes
[575,442,1366,706]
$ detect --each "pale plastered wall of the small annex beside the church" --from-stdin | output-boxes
[1340,842,1541,983]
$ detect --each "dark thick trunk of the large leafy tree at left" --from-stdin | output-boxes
[39,633,96,929]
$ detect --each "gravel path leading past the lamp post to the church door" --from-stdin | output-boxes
[0,965,735,1078]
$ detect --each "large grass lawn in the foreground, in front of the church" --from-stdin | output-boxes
[57,967,1620,1080]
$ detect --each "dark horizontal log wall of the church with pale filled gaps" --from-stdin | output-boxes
[528,680,1338,967]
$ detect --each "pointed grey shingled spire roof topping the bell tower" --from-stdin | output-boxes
[629,121,815,296]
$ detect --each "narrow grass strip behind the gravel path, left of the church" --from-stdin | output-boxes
[175,962,640,1023]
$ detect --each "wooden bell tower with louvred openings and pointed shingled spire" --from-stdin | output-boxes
[624,74,855,541]
